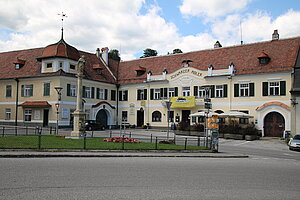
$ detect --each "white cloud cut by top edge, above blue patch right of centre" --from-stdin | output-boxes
[179,0,251,17]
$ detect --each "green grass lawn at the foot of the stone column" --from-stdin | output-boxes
[0,135,206,150]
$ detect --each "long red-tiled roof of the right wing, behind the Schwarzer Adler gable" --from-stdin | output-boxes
[119,37,300,84]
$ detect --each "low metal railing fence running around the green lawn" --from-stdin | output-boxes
[0,126,211,150]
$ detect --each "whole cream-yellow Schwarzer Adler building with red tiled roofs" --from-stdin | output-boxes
[0,30,300,136]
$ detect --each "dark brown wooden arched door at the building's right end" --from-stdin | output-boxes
[264,112,285,137]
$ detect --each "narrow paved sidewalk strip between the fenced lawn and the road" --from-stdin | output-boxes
[0,149,249,158]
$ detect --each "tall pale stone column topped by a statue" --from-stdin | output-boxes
[71,56,85,137]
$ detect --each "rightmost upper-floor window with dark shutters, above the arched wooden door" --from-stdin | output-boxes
[263,81,286,96]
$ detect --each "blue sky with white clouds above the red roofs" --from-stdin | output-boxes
[0,0,300,60]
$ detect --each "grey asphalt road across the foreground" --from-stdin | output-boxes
[0,157,300,200]
